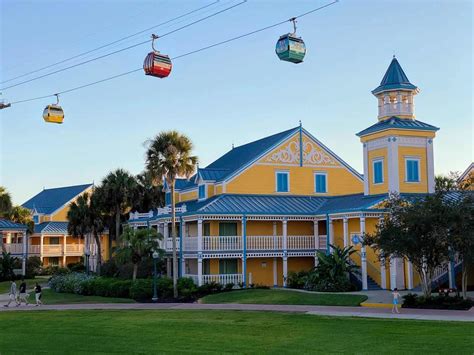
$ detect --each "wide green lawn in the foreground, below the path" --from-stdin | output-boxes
[0,310,474,354]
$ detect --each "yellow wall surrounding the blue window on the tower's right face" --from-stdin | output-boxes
[398,147,428,193]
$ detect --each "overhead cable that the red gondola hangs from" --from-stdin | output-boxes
[0,0,247,91]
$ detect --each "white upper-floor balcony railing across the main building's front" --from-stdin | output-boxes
[164,235,326,253]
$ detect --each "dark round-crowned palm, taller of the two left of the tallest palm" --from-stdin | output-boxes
[96,169,137,250]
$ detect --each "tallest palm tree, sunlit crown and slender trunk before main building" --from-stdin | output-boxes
[145,131,198,298]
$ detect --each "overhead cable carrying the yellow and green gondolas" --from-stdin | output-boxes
[4,0,339,105]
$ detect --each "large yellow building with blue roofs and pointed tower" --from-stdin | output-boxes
[129,58,458,289]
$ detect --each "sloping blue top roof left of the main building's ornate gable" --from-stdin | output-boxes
[206,126,300,180]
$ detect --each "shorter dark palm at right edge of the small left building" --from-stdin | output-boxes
[67,193,105,275]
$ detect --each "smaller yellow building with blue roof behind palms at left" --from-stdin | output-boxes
[20,184,108,269]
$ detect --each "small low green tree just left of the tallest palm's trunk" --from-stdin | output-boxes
[116,226,163,281]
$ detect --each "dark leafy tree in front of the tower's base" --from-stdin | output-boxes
[364,194,450,297]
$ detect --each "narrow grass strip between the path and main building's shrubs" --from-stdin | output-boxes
[201,289,367,306]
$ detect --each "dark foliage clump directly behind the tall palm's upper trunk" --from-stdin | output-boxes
[132,171,165,212]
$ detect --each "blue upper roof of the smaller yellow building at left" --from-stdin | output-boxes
[22,184,92,214]
